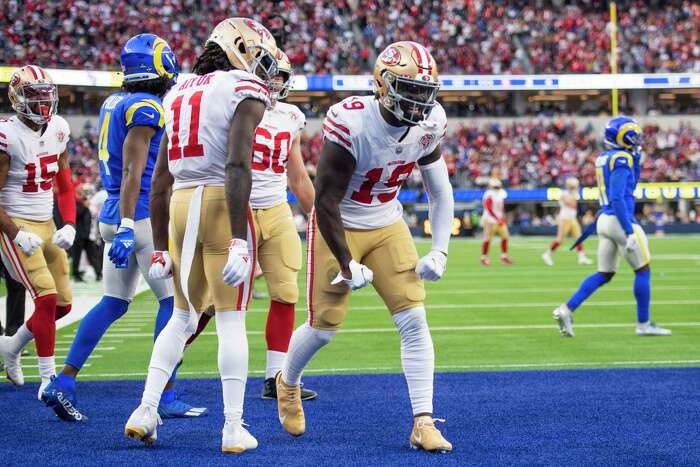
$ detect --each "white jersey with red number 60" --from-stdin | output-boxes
[250,102,306,209]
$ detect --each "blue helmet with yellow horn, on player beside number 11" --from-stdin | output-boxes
[121,34,179,85]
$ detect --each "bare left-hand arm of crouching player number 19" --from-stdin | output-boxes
[314,141,355,279]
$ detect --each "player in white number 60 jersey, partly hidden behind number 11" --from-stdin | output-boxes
[188,51,317,400]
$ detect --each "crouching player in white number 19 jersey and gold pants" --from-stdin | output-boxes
[276,41,454,452]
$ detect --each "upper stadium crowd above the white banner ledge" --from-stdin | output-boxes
[0,0,700,74]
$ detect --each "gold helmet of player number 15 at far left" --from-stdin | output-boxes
[7,65,58,125]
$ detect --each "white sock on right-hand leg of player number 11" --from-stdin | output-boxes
[216,311,248,423]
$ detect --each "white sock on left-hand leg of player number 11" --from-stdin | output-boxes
[141,308,199,410]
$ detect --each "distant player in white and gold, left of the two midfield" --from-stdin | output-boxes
[481,177,513,266]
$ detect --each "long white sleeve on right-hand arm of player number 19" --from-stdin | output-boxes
[418,157,454,254]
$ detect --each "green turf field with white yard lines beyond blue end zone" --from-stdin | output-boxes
[45,236,700,379]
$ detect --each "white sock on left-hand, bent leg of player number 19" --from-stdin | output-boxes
[282,323,336,386]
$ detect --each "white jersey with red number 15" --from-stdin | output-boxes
[0,115,70,221]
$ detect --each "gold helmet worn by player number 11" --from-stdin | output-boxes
[205,18,277,83]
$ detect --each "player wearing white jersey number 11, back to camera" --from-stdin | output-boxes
[124,18,277,452]
